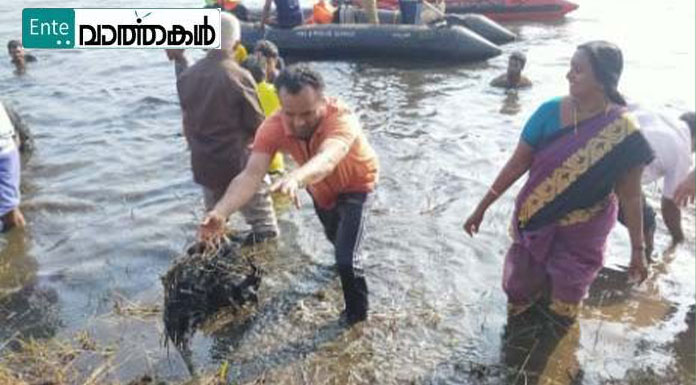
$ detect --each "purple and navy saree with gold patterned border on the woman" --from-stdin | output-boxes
[503,108,653,316]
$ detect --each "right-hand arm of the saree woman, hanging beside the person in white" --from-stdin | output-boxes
[615,166,648,282]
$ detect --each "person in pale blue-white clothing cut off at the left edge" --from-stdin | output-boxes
[0,102,25,232]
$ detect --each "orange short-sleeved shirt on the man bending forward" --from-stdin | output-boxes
[253,99,379,209]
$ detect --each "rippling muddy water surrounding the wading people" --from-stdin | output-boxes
[0,0,696,384]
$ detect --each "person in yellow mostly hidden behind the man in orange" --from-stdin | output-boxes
[242,56,285,175]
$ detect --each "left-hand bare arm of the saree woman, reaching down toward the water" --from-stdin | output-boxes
[464,140,534,236]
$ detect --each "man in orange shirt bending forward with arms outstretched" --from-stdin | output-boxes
[199,65,379,324]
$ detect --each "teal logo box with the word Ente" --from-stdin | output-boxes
[22,8,75,48]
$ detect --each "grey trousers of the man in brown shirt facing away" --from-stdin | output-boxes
[203,177,278,234]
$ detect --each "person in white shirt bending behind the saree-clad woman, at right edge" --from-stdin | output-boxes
[619,105,696,260]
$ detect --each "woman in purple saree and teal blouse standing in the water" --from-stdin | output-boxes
[464,41,653,320]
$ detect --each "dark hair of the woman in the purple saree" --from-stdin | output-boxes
[578,40,626,106]
